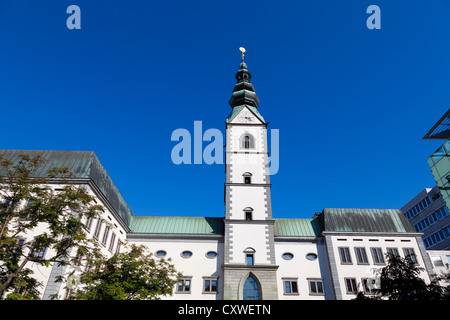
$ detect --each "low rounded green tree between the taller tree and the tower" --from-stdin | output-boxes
[73,244,181,300]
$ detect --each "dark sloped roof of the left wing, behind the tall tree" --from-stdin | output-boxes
[0,150,133,225]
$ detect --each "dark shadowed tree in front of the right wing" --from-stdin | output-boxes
[356,253,444,300]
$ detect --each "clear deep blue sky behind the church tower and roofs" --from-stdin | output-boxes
[0,0,450,218]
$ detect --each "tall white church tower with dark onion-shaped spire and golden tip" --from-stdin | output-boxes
[222,48,278,300]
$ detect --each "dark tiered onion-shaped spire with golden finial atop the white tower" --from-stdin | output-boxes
[228,47,259,108]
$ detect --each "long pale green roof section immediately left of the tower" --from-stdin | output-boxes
[130,216,223,235]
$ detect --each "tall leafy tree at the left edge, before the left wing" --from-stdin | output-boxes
[0,154,102,299]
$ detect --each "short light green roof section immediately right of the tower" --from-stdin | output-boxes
[274,219,321,237]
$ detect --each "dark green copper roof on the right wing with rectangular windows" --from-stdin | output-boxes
[319,208,416,233]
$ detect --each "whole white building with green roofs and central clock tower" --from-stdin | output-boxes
[0,57,446,300]
